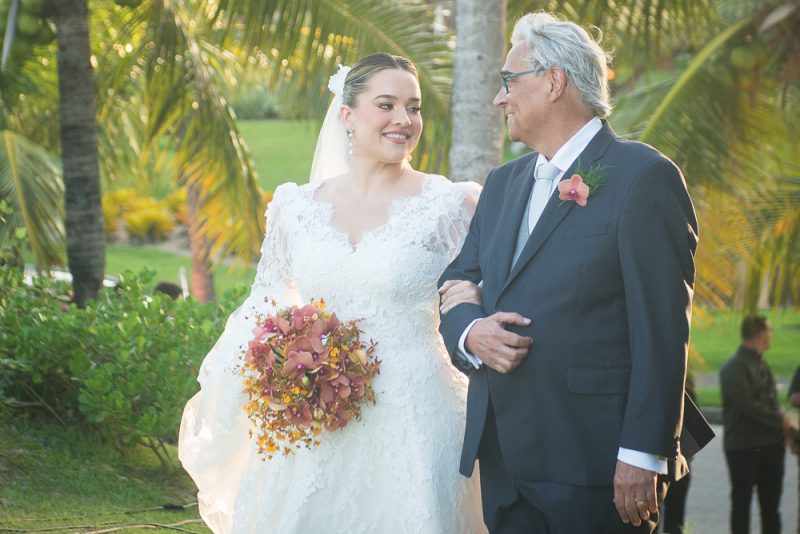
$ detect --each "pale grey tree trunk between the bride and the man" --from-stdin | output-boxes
[450,0,506,183]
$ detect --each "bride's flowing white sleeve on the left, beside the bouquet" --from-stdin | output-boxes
[178,184,296,533]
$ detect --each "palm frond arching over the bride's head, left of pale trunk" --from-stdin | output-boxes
[212,0,452,172]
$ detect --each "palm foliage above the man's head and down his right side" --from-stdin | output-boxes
[500,0,800,309]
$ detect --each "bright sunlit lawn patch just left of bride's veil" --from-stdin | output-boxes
[238,120,319,191]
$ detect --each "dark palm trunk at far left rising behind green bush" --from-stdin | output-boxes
[51,0,105,307]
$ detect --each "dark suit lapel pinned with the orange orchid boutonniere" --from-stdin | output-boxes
[500,121,616,293]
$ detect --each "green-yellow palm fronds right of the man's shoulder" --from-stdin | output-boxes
[608,2,800,310]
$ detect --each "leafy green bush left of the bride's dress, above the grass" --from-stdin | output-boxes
[0,267,244,462]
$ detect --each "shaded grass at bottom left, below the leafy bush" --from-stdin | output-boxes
[0,417,209,532]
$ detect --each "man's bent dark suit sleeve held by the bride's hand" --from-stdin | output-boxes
[438,174,491,374]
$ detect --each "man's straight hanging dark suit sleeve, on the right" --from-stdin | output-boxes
[619,158,698,458]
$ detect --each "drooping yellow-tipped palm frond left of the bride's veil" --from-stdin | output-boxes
[134,0,264,261]
